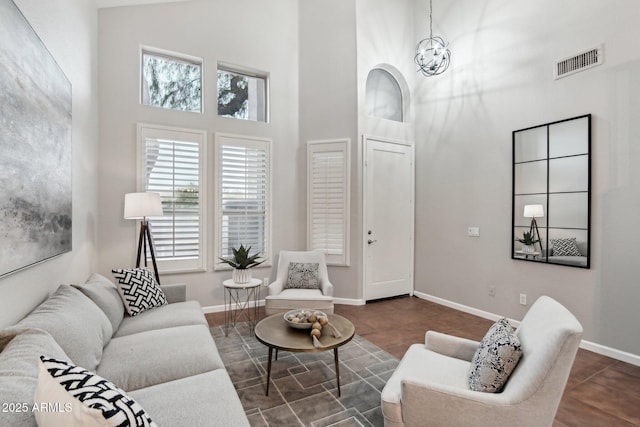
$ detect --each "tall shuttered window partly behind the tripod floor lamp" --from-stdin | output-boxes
[138,124,207,273]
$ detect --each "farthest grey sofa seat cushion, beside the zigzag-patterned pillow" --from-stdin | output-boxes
[114,301,207,337]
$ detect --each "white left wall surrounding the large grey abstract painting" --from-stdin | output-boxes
[0,0,98,327]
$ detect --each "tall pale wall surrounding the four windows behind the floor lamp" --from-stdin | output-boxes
[98,0,305,308]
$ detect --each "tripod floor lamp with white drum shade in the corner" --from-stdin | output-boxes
[124,193,162,285]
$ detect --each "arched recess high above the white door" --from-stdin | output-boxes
[366,68,404,122]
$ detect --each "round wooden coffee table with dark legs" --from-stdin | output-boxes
[254,313,356,396]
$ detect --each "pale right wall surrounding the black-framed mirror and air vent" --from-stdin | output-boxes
[415,0,640,355]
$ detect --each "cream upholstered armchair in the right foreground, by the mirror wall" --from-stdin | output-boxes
[381,296,582,427]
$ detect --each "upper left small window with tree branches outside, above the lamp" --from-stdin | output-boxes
[140,47,202,113]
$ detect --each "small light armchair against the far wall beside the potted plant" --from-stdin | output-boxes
[265,251,333,315]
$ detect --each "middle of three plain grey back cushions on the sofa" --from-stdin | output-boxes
[18,285,113,370]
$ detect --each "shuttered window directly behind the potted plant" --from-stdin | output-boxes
[215,134,271,268]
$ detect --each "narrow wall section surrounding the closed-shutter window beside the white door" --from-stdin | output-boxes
[298,0,362,300]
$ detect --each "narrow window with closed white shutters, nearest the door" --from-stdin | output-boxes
[307,139,351,265]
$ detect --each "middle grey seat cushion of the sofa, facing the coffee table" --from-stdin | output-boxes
[97,325,224,391]
